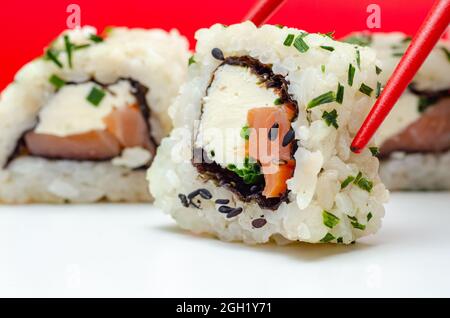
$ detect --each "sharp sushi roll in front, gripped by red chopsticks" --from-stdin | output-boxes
[148,22,388,244]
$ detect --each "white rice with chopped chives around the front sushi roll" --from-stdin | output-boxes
[148,22,388,244]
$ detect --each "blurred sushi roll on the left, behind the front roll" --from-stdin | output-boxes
[0,27,189,203]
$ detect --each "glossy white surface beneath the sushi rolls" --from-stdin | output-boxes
[0,193,450,297]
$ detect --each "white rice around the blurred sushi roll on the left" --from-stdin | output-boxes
[0,27,189,203]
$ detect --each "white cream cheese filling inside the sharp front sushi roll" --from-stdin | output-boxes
[195,65,279,167]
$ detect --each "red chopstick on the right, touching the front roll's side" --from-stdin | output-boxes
[351,0,450,153]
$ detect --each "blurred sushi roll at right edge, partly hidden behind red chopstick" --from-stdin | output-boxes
[346,32,450,190]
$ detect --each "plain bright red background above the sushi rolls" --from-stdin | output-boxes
[0,0,440,89]
